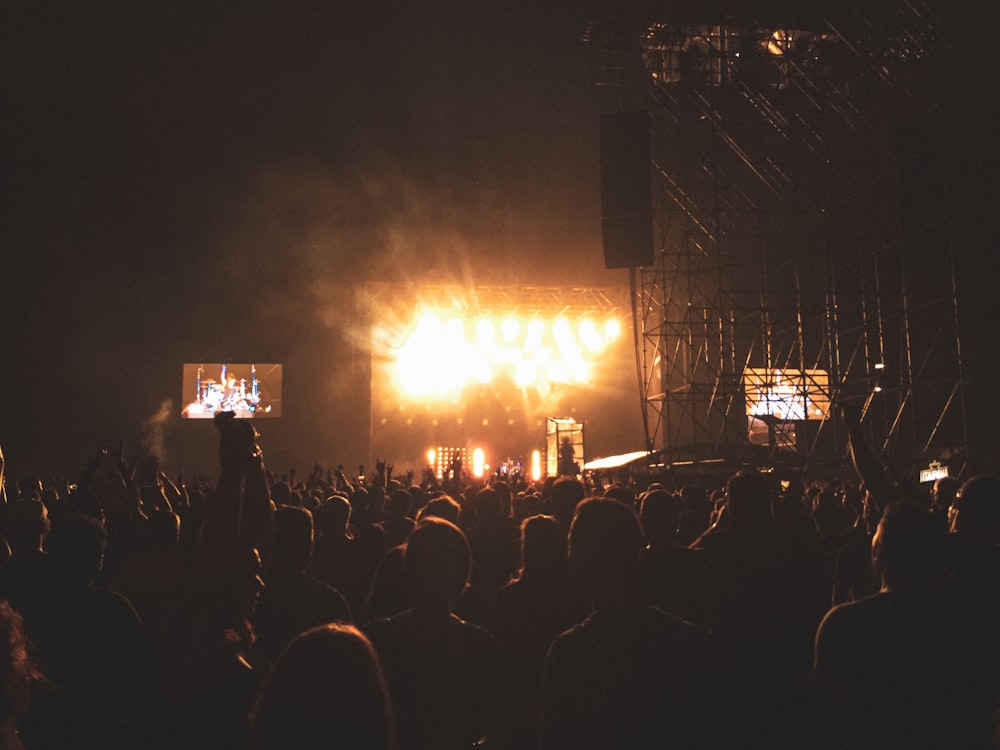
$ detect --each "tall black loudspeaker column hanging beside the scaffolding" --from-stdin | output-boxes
[601,110,653,268]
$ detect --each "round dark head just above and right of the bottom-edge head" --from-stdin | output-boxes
[404,517,470,605]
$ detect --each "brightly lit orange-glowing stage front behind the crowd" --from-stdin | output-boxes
[371,286,643,471]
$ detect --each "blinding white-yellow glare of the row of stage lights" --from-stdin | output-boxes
[393,308,622,399]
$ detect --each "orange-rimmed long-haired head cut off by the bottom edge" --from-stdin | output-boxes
[251,624,395,750]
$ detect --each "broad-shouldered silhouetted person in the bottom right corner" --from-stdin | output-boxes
[813,502,1000,750]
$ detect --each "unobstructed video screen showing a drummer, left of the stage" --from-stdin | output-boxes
[181,362,281,419]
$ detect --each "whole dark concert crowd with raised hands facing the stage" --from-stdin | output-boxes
[0,416,1000,750]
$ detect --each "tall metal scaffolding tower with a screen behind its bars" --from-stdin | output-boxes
[587,0,968,475]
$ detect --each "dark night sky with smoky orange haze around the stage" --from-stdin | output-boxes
[0,0,1000,476]
